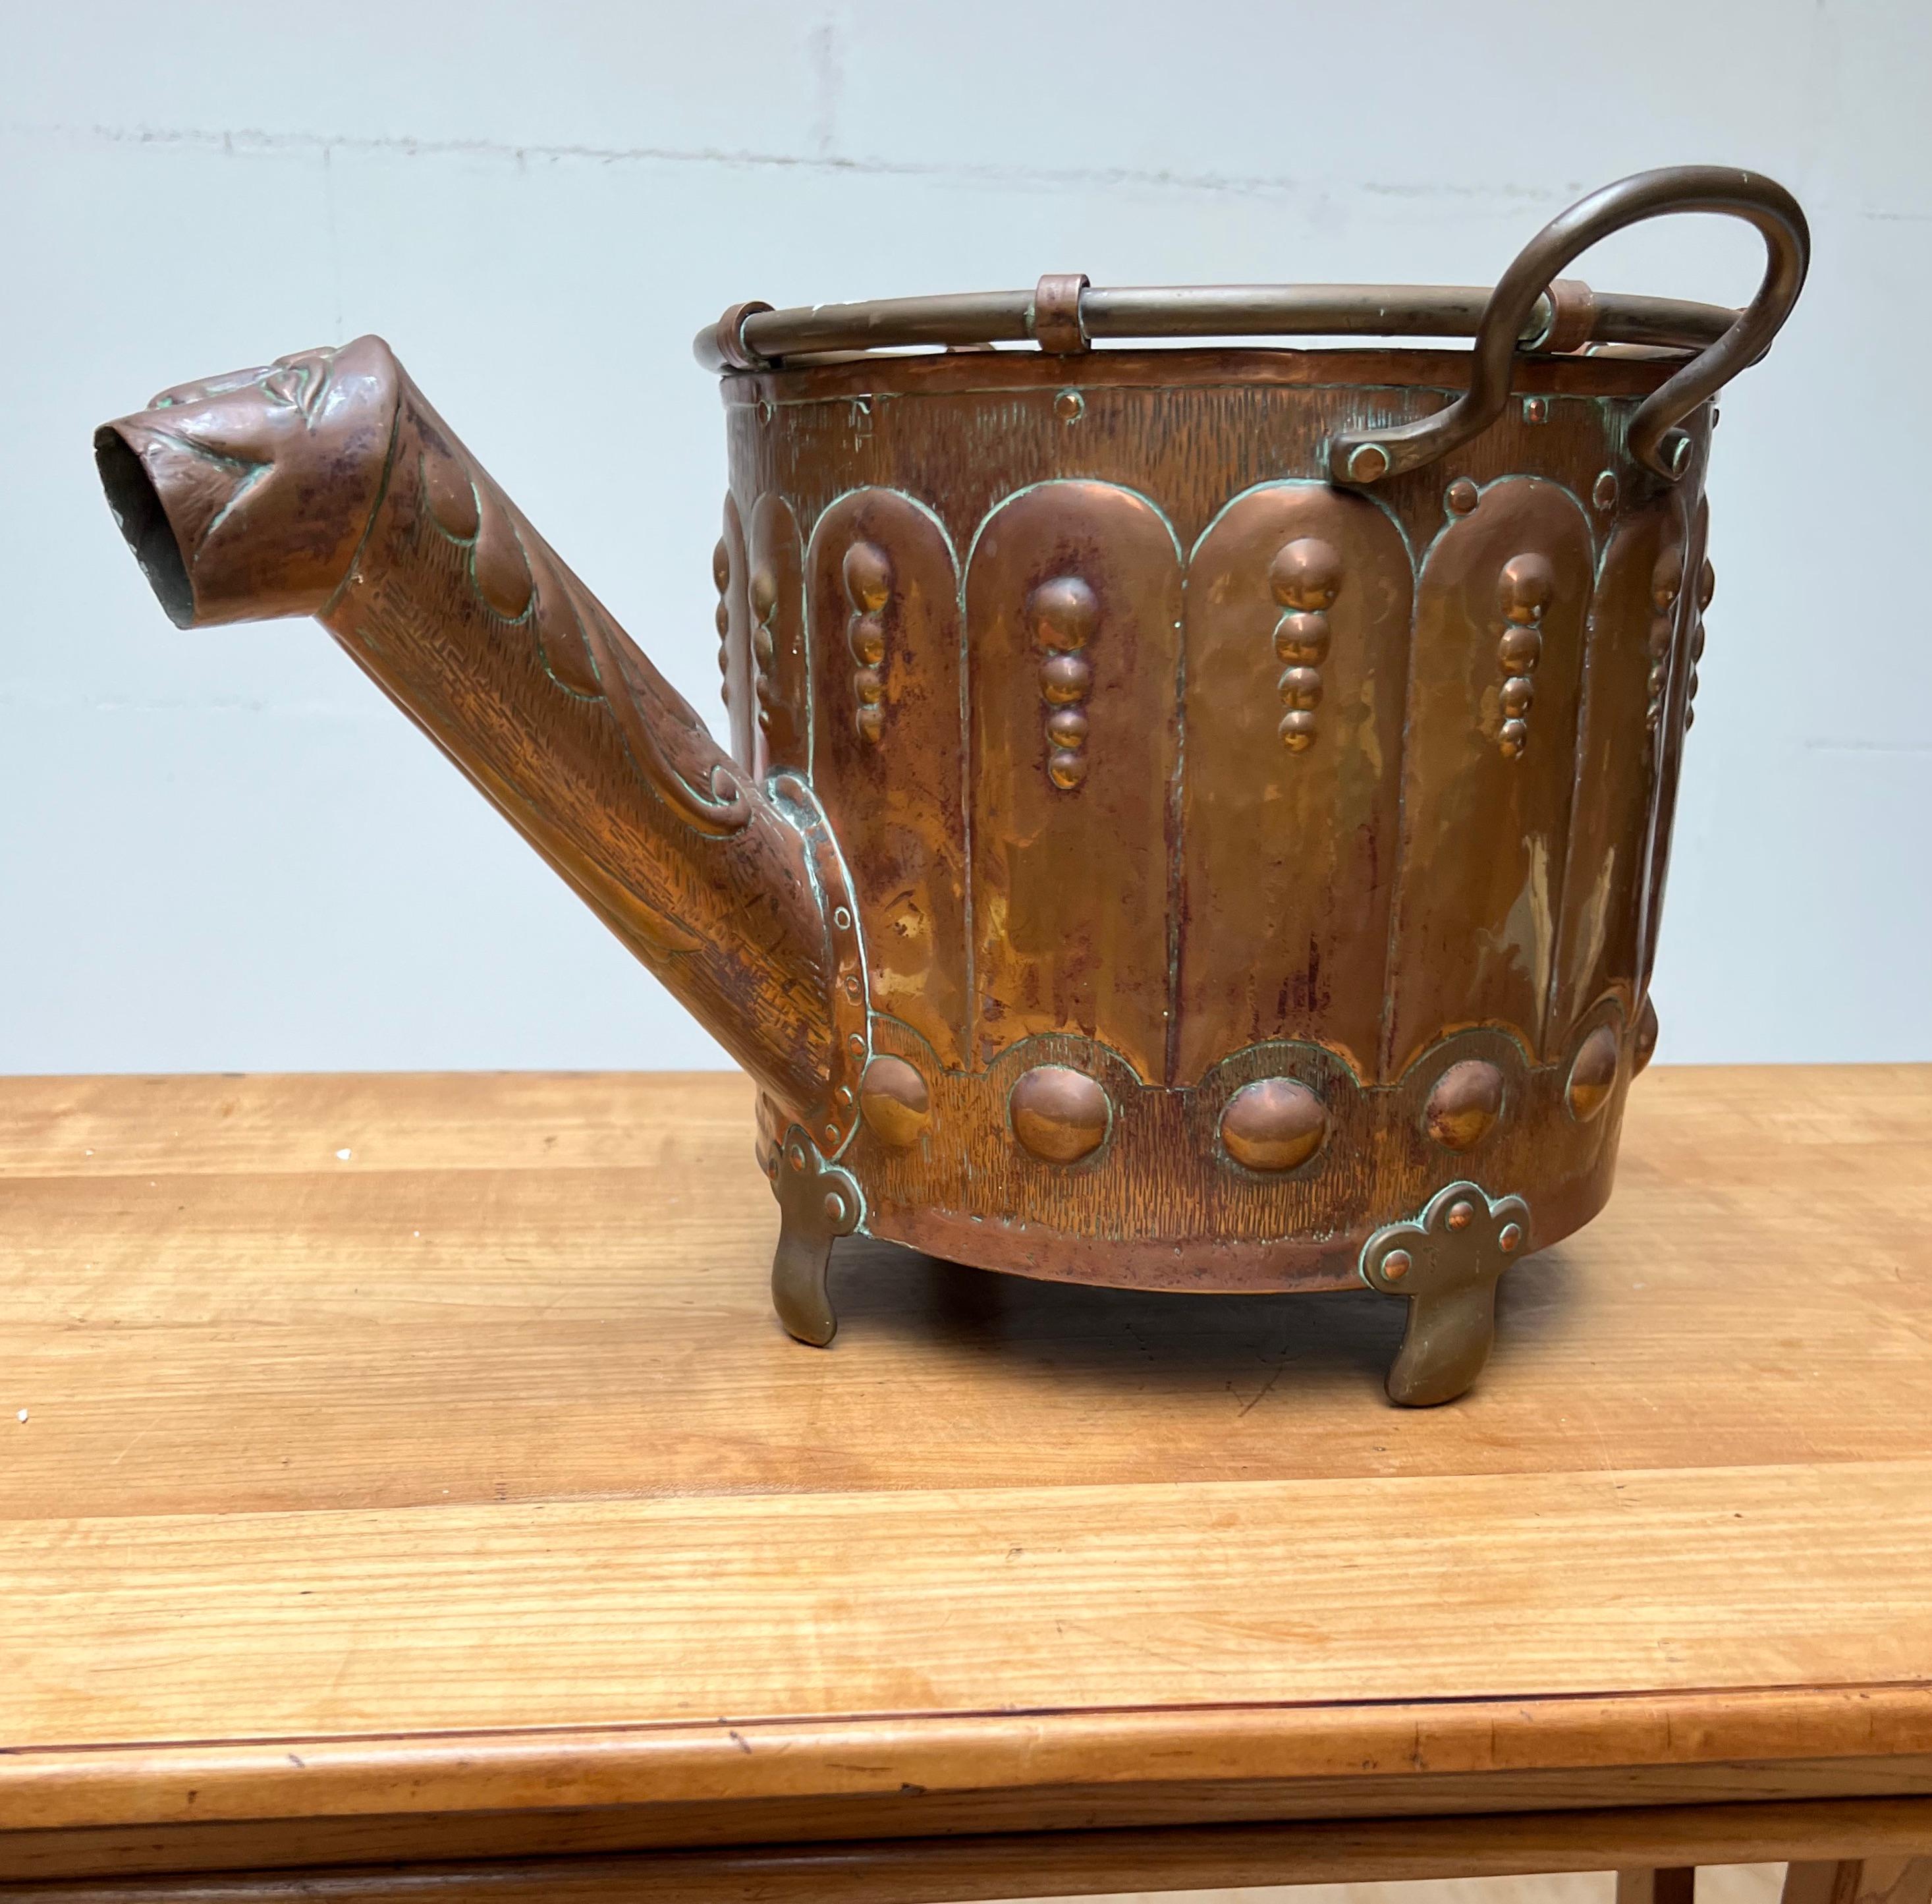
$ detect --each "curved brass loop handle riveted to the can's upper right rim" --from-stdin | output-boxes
[1329,166,1810,485]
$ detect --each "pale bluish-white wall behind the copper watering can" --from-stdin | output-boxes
[0,0,1932,1071]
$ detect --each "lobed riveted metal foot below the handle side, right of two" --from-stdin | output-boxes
[1362,1183,1530,1407]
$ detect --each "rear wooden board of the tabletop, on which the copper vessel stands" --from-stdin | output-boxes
[0,1067,1932,1519]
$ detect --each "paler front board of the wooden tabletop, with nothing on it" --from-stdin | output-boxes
[11,1461,1932,1745]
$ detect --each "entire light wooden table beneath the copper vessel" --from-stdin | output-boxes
[0,1067,1932,1904]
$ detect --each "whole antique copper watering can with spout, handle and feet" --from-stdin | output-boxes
[95,168,1808,1403]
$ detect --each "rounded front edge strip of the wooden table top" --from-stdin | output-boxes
[0,1682,1932,1831]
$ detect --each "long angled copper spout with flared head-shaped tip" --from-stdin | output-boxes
[95,337,864,1150]
